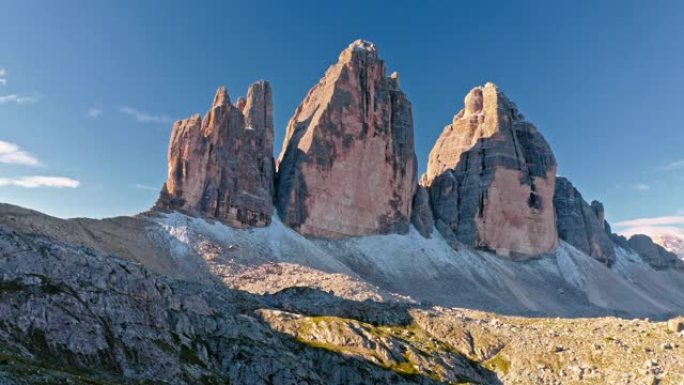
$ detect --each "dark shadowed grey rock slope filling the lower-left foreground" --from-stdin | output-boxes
[0,227,498,385]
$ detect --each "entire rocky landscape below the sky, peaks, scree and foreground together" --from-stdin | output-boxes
[0,40,684,385]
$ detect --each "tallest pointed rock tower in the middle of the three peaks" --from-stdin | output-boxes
[276,40,416,238]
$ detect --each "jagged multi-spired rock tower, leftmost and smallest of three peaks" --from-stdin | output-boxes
[156,81,275,227]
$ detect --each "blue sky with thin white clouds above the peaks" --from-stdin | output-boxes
[0,0,684,237]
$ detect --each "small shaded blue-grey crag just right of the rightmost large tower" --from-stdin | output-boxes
[553,177,615,266]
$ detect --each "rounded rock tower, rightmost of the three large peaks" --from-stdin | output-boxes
[421,83,558,256]
